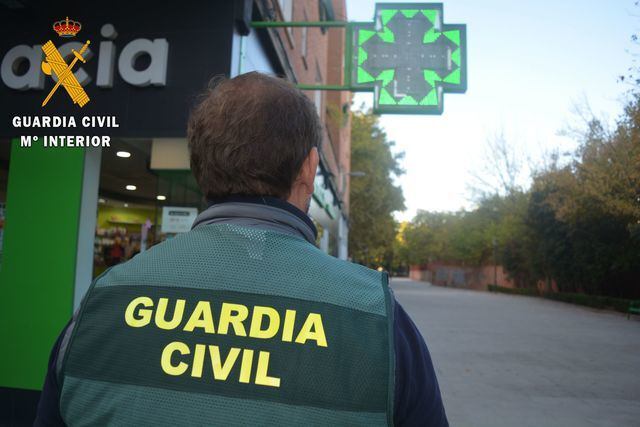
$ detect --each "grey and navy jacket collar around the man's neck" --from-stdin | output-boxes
[191,195,318,245]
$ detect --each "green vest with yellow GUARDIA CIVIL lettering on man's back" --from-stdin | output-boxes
[60,224,395,426]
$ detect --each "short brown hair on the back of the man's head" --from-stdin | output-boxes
[187,72,322,199]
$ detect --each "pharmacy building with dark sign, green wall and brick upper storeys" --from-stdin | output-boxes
[0,0,351,424]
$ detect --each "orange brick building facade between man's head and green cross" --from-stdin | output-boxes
[261,0,351,259]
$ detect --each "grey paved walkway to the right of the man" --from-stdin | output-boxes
[392,279,640,427]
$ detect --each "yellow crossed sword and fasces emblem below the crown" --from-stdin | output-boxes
[42,40,90,107]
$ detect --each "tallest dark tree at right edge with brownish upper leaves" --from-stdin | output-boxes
[530,96,640,298]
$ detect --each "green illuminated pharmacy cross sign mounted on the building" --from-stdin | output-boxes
[350,3,467,114]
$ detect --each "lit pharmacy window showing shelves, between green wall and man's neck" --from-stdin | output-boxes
[93,139,206,277]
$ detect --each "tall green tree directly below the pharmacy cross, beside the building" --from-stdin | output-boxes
[349,111,405,268]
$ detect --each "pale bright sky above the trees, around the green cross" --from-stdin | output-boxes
[347,0,640,219]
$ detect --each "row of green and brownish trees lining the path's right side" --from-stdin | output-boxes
[400,95,640,298]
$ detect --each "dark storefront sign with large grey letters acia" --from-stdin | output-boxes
[0,0,234,138]
